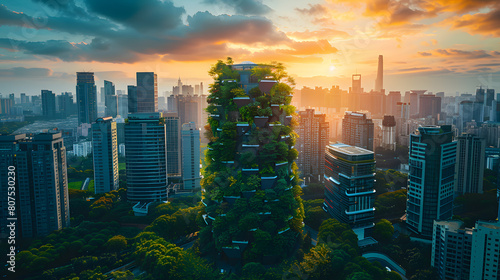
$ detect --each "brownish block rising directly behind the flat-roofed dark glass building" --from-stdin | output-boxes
[342,111,374,151]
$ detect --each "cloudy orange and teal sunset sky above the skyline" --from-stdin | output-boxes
[0,0,500,97]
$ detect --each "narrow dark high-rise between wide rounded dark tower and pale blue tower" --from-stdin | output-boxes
[164,113,182,179]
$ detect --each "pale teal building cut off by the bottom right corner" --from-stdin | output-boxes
[469,221,500,280]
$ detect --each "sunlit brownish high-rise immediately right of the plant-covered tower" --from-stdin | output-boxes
[296,109,330,181]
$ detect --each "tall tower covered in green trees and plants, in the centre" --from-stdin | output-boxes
[200,58,304,262]
